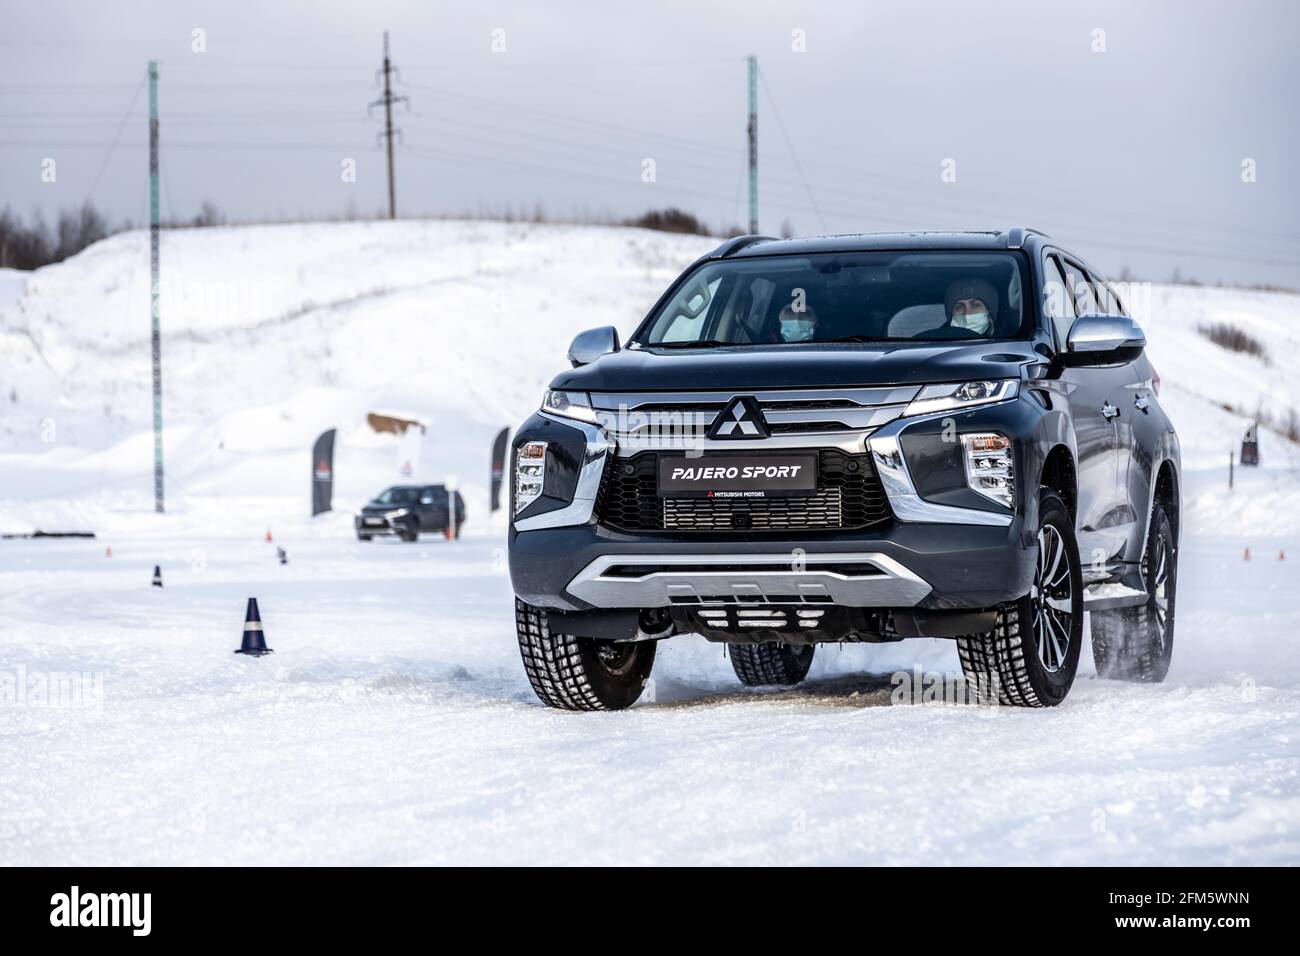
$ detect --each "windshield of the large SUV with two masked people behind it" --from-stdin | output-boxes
[633,252,1028,349]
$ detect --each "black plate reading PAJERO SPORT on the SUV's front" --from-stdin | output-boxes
[659,454,816,499]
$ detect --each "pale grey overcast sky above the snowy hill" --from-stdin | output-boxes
[0,0,1300,286]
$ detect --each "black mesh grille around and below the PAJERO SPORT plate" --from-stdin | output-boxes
[597,449,891,532]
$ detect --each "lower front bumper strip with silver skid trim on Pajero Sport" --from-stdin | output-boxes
[510,520,1034,610]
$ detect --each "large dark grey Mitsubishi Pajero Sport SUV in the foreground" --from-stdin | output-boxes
[510,229,1179,710]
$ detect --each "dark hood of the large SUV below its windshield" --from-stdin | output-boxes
[551,341,1043,392]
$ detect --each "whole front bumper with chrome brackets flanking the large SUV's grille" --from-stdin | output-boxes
[510,401,1041,611]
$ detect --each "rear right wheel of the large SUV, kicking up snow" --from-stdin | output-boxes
[1091,503,1178,684]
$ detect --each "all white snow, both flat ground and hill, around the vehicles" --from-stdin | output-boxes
[0,222,1300,864]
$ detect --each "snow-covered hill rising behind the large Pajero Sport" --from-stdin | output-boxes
[0,222,1300,533]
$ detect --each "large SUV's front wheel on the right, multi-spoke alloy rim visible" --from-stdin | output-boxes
[957,489,1083,708]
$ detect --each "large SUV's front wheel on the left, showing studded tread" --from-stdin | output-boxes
[515,598,654,710]
